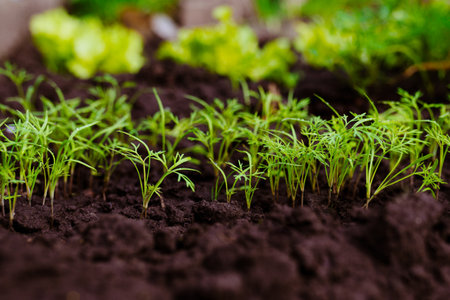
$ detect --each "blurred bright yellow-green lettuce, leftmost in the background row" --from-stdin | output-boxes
[30,8,145,79]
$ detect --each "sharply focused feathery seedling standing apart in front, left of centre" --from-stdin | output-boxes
[116,132,196,218]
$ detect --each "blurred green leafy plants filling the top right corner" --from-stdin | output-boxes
[295,1,450,87]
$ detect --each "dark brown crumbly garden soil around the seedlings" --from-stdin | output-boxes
[0,36,450,300]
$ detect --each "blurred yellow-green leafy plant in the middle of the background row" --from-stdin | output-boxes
[158,7,298,87]
